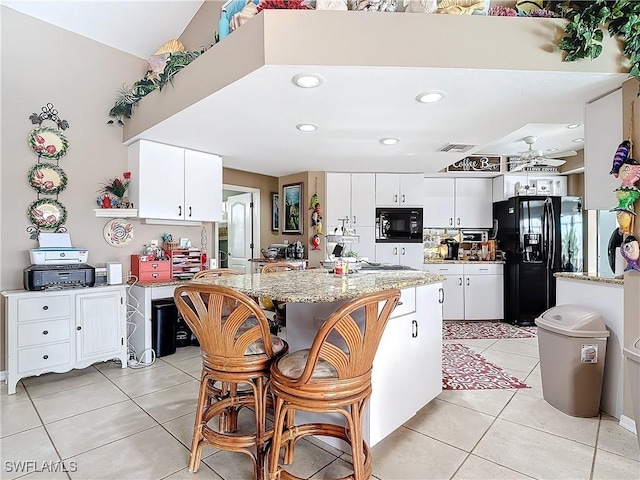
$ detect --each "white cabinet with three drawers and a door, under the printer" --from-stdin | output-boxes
[2,285,127,394]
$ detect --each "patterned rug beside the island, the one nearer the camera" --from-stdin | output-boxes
[442,343,531,390]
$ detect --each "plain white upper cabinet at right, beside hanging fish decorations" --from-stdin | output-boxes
[584,89,620,210]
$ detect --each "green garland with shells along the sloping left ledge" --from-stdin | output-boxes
[107,47,210,126]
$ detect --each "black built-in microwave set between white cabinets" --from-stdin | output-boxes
[376,207,422,243]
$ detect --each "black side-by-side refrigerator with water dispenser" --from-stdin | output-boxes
[493,196,583,326]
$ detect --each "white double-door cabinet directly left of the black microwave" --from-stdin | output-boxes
[324,173,376,228]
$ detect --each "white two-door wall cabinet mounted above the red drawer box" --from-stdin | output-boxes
[129,140,222,224]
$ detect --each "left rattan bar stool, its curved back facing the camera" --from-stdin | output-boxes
[174,283,288,479]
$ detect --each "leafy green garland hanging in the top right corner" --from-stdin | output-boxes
[558,0,640,96]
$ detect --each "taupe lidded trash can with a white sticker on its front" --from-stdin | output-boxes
[535,305,609,417]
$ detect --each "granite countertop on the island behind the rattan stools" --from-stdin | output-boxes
[191,269,444,303]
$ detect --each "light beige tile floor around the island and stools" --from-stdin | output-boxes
[0,338,640,480]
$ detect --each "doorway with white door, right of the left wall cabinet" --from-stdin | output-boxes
[214,184,260,273]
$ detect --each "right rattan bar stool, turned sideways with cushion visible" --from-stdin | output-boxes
[268,289,400,480]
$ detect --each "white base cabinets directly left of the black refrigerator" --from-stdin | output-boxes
[424,262,504,320]
